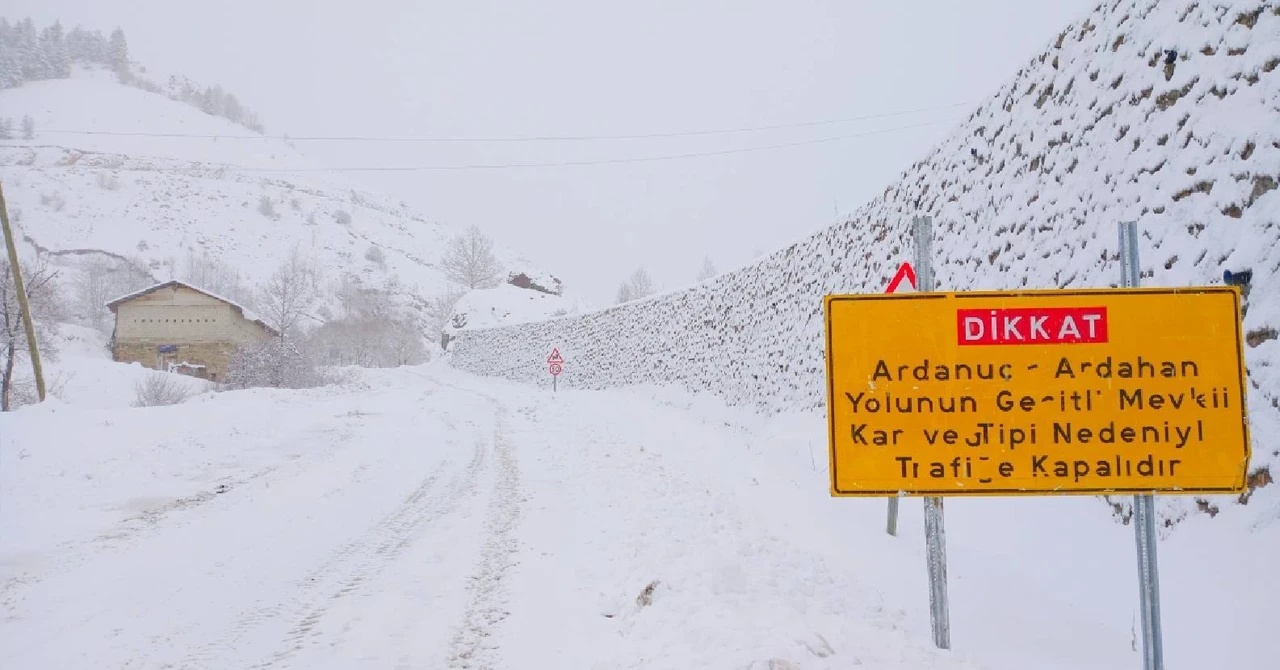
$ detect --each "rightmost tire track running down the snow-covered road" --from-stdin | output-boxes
[440,398,521,669]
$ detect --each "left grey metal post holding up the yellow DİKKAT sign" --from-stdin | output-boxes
[911,217,951,650]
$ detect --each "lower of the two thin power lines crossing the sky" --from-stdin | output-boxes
[0,120,952,173]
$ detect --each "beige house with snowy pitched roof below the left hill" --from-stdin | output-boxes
[106,281,279,382]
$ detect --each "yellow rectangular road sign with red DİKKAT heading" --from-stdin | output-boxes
[826,287,1251,496]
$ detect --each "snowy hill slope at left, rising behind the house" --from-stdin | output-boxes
[0,68,560,326]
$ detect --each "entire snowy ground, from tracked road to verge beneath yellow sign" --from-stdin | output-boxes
[0,363,1280,670]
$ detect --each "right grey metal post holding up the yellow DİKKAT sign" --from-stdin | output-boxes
[1120,222,1165,670]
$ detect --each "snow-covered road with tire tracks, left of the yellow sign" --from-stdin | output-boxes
[0,368,972,670]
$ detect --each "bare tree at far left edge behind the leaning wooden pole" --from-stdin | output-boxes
[0,256,65,411]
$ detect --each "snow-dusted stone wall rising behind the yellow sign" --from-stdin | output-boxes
[452,0,1280,519]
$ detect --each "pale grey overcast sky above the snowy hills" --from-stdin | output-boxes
[0,0,1093,304]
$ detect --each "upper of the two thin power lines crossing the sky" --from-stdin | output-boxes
[40,102,970,142]
